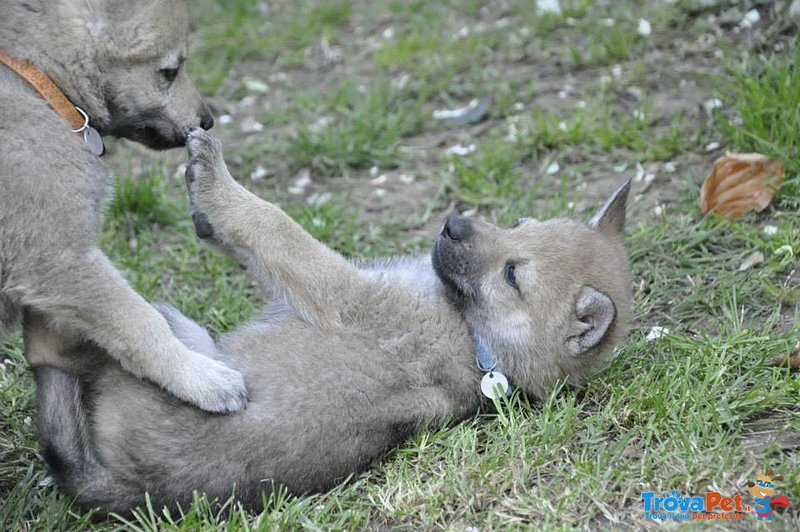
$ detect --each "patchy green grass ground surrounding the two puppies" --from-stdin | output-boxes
[0,0,800,530]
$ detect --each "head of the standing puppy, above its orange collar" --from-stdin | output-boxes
[54,0,214,149]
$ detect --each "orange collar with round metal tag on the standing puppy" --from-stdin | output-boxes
[0,50,105,156]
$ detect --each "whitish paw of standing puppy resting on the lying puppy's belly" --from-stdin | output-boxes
[172,351,247,414]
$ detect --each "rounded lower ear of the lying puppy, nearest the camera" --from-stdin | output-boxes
[566,286,617,356]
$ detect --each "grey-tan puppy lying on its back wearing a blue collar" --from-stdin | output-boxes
[29,130,631,512]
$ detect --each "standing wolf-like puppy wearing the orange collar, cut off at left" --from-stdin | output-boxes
[0,0,246,412]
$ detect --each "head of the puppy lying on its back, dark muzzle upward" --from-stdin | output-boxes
[433,183,631,398]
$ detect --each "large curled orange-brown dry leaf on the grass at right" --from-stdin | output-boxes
[700,153,786,218]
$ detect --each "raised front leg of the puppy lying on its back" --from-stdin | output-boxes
[186,129,363,327]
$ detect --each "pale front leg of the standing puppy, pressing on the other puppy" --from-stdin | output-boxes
[15,249,247,412]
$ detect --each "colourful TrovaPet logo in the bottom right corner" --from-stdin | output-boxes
[642,470,792,521]
